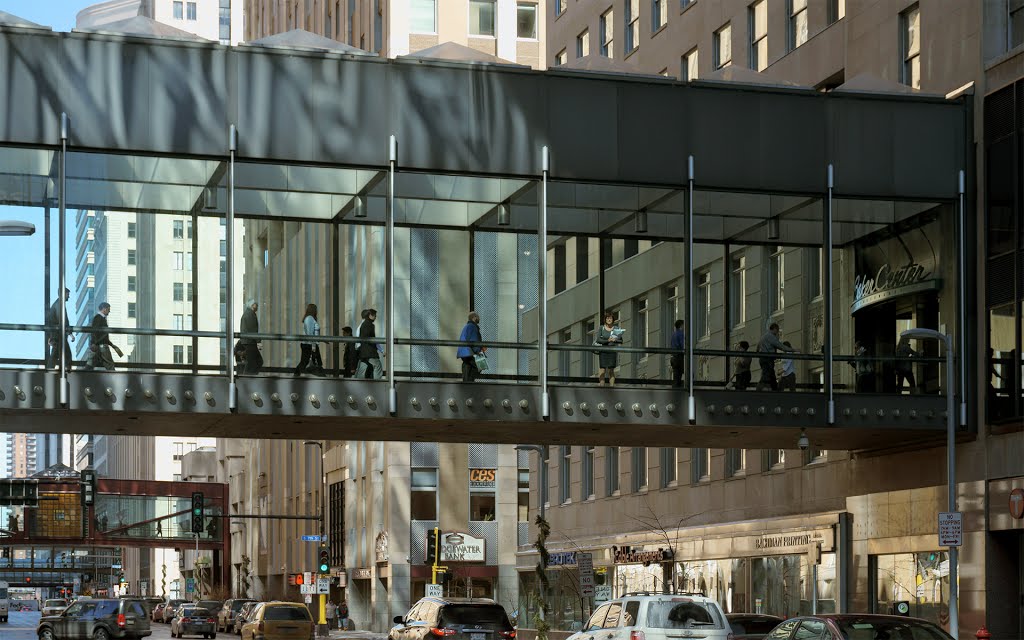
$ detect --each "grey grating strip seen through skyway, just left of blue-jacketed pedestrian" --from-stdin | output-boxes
[409,228,441,372]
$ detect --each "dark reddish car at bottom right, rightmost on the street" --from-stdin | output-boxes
[765,613,952,640]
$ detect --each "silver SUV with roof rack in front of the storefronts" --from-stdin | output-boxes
[568,593,731,640]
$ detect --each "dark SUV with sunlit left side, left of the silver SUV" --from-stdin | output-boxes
[388,598,516,640]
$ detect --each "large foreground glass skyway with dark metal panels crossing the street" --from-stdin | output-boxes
[0,18,977,450]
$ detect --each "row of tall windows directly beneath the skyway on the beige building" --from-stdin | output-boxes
[541,445,827,504]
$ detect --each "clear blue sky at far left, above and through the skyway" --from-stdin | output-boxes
[0,0,96,357]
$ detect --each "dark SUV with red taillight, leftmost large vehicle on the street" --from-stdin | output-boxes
[36,598,152,640]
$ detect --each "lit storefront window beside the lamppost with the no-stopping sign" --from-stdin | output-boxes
[871,551,949,626]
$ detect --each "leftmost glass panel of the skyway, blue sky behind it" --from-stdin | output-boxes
[0,147,58,368]
